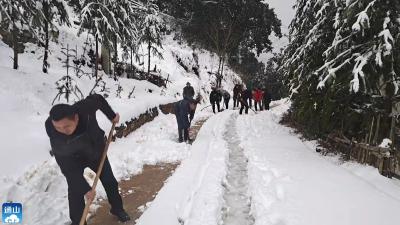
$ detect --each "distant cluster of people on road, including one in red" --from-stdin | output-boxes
[210,84,271,114]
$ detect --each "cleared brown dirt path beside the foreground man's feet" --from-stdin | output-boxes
[88,118,207,225]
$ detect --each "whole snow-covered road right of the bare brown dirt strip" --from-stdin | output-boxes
[138,101,400,225]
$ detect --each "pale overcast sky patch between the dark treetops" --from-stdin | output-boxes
[259,0,296,62]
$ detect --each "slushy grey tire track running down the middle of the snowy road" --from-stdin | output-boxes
[222,115,254,225]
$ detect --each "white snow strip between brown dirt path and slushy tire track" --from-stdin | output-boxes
[137,111,232,225]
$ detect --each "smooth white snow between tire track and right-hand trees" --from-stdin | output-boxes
[237,102,400,225]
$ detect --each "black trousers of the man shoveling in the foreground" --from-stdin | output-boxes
[68,158,123,225]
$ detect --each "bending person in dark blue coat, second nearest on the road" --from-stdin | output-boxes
[174,99,196,142]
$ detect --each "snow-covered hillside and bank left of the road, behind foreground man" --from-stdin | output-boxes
[0,14,240,225]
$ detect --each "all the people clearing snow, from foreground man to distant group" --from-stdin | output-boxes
[45,82,271,225]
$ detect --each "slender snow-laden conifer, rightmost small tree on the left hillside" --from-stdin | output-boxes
[139,0,165,75]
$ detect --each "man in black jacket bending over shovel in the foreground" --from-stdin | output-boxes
[45,94,130,225]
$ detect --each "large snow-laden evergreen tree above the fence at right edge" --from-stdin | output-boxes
[283,0,400,140]
